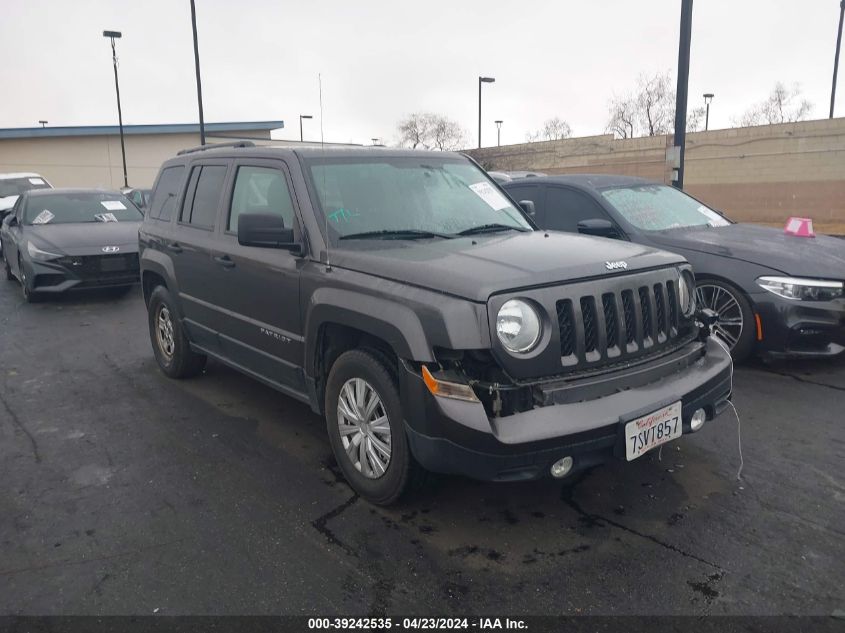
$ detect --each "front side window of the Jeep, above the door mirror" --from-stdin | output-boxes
[228,165,295,232]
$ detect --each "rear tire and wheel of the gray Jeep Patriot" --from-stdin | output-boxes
[147,286,207,378]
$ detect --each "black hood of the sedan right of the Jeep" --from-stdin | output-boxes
[649,224,845,279]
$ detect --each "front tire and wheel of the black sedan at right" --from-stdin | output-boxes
[695,279,756,363]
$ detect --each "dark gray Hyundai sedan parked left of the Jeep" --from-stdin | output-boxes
[0,189,143,301]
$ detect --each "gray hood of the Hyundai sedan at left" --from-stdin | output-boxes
[26,222,141,255]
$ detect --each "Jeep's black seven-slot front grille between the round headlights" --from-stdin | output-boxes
[556,280,678,367]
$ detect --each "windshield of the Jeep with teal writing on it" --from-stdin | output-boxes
[304,155,531,242]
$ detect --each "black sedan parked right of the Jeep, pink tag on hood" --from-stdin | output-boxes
[502,174,845,360]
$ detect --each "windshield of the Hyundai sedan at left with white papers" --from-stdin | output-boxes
[24,192,143,224]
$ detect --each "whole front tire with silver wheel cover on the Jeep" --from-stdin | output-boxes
[325,350,422,505]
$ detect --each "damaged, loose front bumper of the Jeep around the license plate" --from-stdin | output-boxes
[401,339,732,481]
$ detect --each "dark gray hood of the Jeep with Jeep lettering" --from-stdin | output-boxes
[331,231,685,302]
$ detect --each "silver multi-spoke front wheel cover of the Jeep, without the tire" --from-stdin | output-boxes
[337,378,391,479]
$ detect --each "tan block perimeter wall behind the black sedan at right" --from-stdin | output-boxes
[467,118,845,232]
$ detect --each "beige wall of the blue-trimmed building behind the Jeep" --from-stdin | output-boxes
[0,131,270,189]
